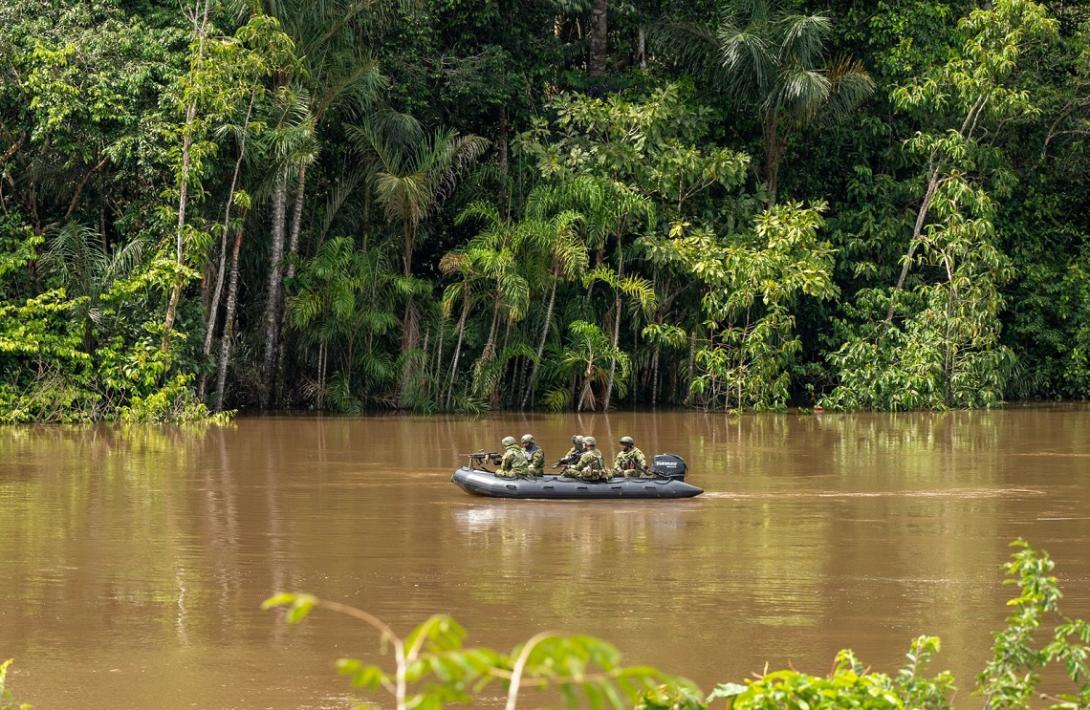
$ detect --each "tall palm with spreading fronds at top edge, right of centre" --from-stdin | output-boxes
[663,0,874,206]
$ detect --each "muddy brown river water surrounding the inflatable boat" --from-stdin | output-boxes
[0,407,1090,710]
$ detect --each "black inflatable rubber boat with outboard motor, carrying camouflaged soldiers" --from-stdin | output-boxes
[450,454,704,500]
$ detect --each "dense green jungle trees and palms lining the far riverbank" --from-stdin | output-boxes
[0,0,1090,422]
